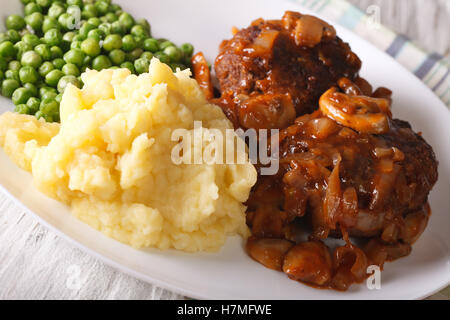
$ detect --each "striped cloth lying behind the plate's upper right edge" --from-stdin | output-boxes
[290,0,450,300]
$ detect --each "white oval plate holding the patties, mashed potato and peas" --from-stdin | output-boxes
[0,0,450,299]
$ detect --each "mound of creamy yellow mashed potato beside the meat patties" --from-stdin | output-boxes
[0,59,256,252]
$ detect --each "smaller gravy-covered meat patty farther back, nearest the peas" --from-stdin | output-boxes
[215,12,361,129]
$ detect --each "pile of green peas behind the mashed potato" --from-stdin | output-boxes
[0,0,194,122]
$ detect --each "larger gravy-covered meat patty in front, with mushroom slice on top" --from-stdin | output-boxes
[247,79,438,290]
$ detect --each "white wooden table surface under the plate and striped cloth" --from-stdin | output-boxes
[0,0,450,299]
